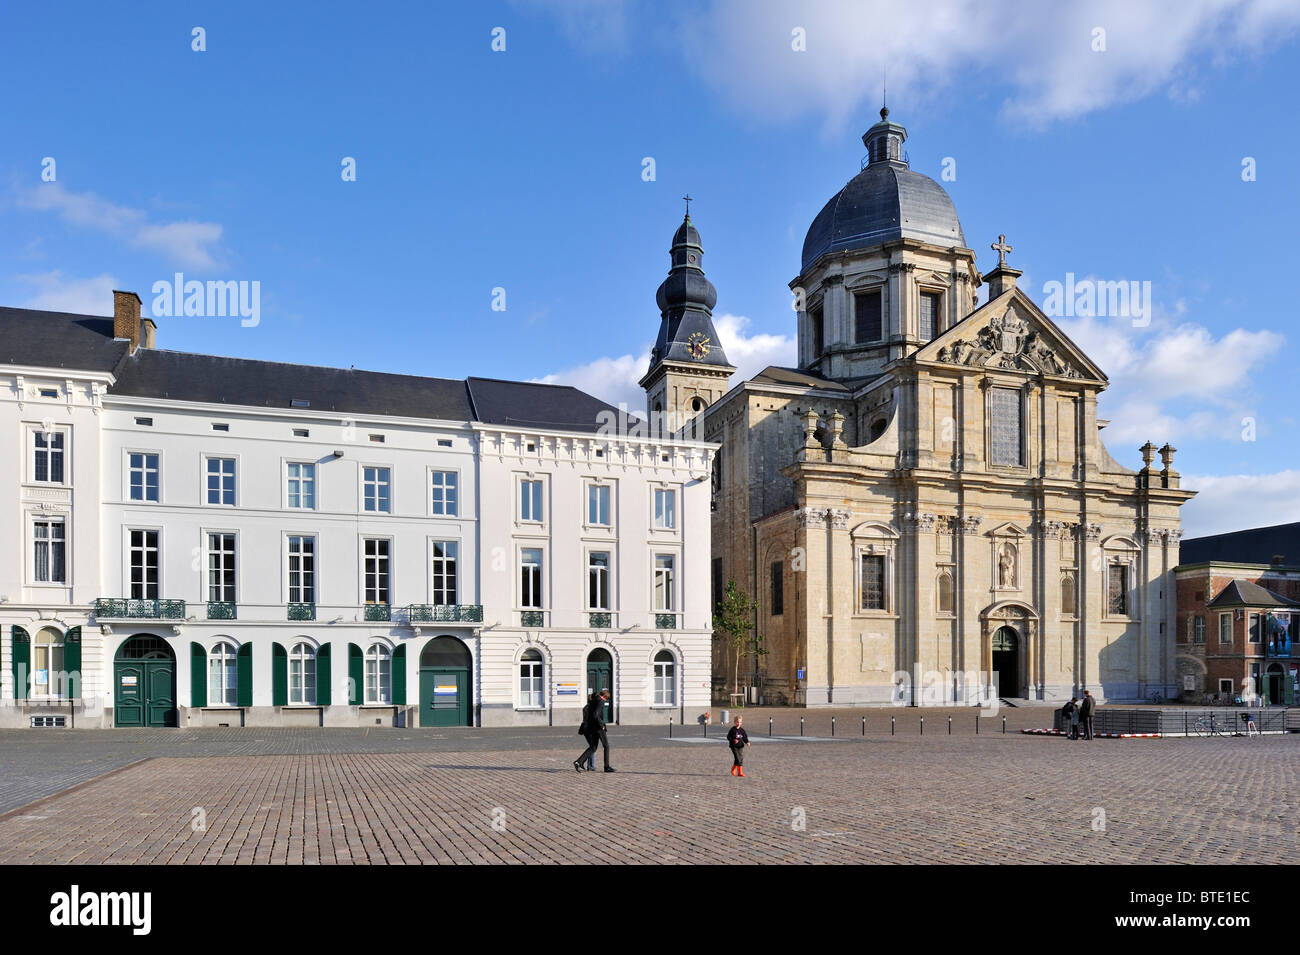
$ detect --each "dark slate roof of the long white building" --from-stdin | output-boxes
[0,308,629,431]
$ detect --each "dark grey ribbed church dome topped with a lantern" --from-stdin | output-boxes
[803,109,966,269]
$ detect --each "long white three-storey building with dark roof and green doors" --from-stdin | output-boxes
[0,292,714,728]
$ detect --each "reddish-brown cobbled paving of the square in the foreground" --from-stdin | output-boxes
[0,720,1300,864]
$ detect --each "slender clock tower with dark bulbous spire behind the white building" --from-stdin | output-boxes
[641,210,736,433]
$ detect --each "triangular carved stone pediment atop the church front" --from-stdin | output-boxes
[917,288,1106,382]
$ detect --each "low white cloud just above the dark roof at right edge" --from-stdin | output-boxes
[1182,470,1300,537]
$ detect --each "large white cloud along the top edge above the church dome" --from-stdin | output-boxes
[680,0,1300,127]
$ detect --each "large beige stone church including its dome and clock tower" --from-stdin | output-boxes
[644,110,1193,706]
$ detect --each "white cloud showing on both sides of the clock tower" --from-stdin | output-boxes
[536,314,796,413]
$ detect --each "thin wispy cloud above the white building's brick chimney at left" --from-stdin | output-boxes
[18,182,222,269]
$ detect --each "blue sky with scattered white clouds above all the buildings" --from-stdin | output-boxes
[0,0,1300,534]
